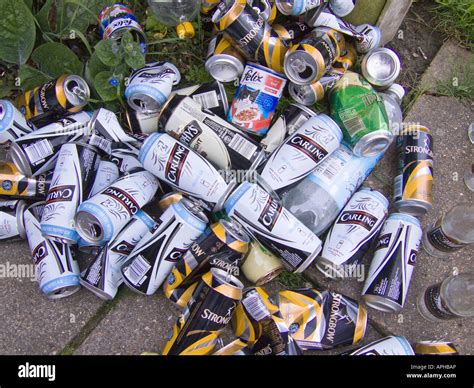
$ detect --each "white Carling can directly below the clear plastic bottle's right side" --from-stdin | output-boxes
[316,187,388,278]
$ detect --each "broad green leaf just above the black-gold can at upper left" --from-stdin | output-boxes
[31,42,83,78]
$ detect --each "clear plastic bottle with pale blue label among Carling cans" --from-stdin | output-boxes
[281,145,383,235]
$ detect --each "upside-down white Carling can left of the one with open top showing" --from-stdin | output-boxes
[41,143,100,244]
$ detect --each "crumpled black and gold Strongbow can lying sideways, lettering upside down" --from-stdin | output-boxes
[278,289,367,350]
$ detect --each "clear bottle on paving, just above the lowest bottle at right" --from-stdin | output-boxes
[423,203,474,257]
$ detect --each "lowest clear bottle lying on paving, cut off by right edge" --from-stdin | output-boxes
[417,273,474,322]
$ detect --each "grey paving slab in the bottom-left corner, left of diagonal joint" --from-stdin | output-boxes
[0,242,102,355]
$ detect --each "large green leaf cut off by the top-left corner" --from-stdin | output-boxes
[0,0,36,65]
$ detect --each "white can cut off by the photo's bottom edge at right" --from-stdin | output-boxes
[342,335,415,356]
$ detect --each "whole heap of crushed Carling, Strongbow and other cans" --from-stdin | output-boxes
[0,0,456,355]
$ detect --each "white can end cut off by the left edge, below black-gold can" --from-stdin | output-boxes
[0,200,26,242]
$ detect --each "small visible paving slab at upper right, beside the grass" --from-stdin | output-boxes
[420,40,474,91]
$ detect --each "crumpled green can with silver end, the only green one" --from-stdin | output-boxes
[329,72,393,157]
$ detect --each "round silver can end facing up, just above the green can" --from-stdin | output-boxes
[360,47,401,89]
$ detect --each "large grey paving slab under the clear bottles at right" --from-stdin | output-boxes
[305,96,474,354]
